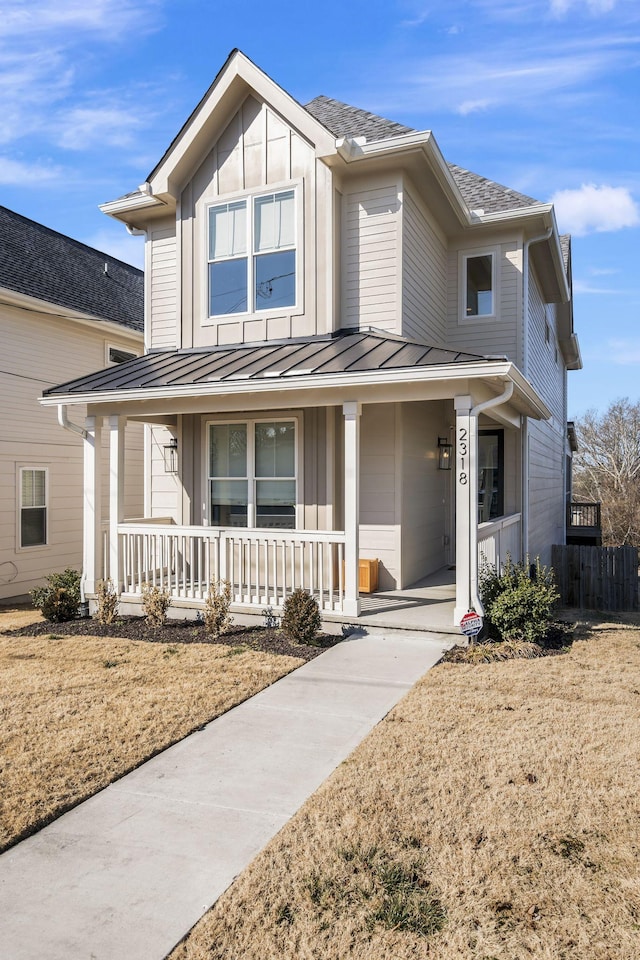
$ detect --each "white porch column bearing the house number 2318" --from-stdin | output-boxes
[453,396,478,625]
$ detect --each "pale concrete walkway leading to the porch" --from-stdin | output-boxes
[0,634,452,960]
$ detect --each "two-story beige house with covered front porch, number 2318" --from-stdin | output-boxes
[38,51,580,622]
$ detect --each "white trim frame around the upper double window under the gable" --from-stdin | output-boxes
[202,179,304,326]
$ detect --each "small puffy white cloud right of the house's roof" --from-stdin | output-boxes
[551,183,640,236]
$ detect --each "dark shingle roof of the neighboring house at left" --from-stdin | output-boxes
[0,206,144,332]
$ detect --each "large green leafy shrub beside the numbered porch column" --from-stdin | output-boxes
[479,557,560,643]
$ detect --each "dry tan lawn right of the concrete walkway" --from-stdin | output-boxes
[171,623,640,960]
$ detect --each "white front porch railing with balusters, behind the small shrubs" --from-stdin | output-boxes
[118,521,345,612]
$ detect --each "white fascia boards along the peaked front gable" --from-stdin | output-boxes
[147,50,336,195]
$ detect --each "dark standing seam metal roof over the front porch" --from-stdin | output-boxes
[43,330,504,397]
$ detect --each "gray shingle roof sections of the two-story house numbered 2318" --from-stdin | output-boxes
[304,96,540,213]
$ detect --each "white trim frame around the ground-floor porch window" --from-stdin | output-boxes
[202,410,304,533]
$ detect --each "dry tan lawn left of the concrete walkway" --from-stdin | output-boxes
[0,609,302,849]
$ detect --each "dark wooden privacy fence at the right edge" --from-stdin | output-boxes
[551,546,638,610]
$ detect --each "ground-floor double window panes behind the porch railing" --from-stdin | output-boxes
[209,420,297,529]
